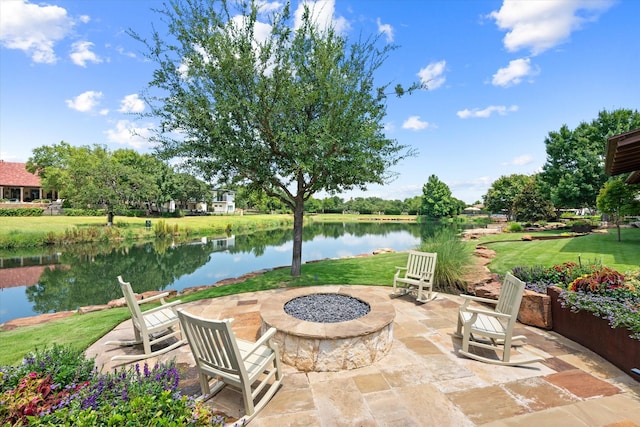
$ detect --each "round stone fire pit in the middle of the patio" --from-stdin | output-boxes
[260,286,395,372]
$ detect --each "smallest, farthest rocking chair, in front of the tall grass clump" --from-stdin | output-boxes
[392,251,438,302]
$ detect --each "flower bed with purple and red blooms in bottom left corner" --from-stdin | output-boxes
[0,346,230,426]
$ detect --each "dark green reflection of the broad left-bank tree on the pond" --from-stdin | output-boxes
[26,243,214,313]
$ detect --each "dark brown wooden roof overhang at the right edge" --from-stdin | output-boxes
[605,129,640,184]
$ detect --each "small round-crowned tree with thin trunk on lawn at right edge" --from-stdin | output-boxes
[597,178,640,241]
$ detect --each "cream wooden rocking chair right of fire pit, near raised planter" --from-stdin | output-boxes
[454,273,544,366]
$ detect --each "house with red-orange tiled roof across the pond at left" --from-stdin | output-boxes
[0,160,57,202]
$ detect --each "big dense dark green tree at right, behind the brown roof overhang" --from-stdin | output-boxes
[540,109,640,208]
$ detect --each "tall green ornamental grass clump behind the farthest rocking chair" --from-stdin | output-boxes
[420,228,472,295]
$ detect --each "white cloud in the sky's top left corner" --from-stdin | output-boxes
[0,0,73,64]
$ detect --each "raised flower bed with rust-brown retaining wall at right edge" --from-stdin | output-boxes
[513,263,640,380]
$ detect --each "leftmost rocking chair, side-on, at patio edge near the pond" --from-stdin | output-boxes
[106,276,186,360]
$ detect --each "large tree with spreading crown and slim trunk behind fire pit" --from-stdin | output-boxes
[131,0,418,276]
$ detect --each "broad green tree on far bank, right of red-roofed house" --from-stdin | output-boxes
[27,141,211,223]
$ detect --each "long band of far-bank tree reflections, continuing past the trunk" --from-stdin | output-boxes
[26,223,437,313]
